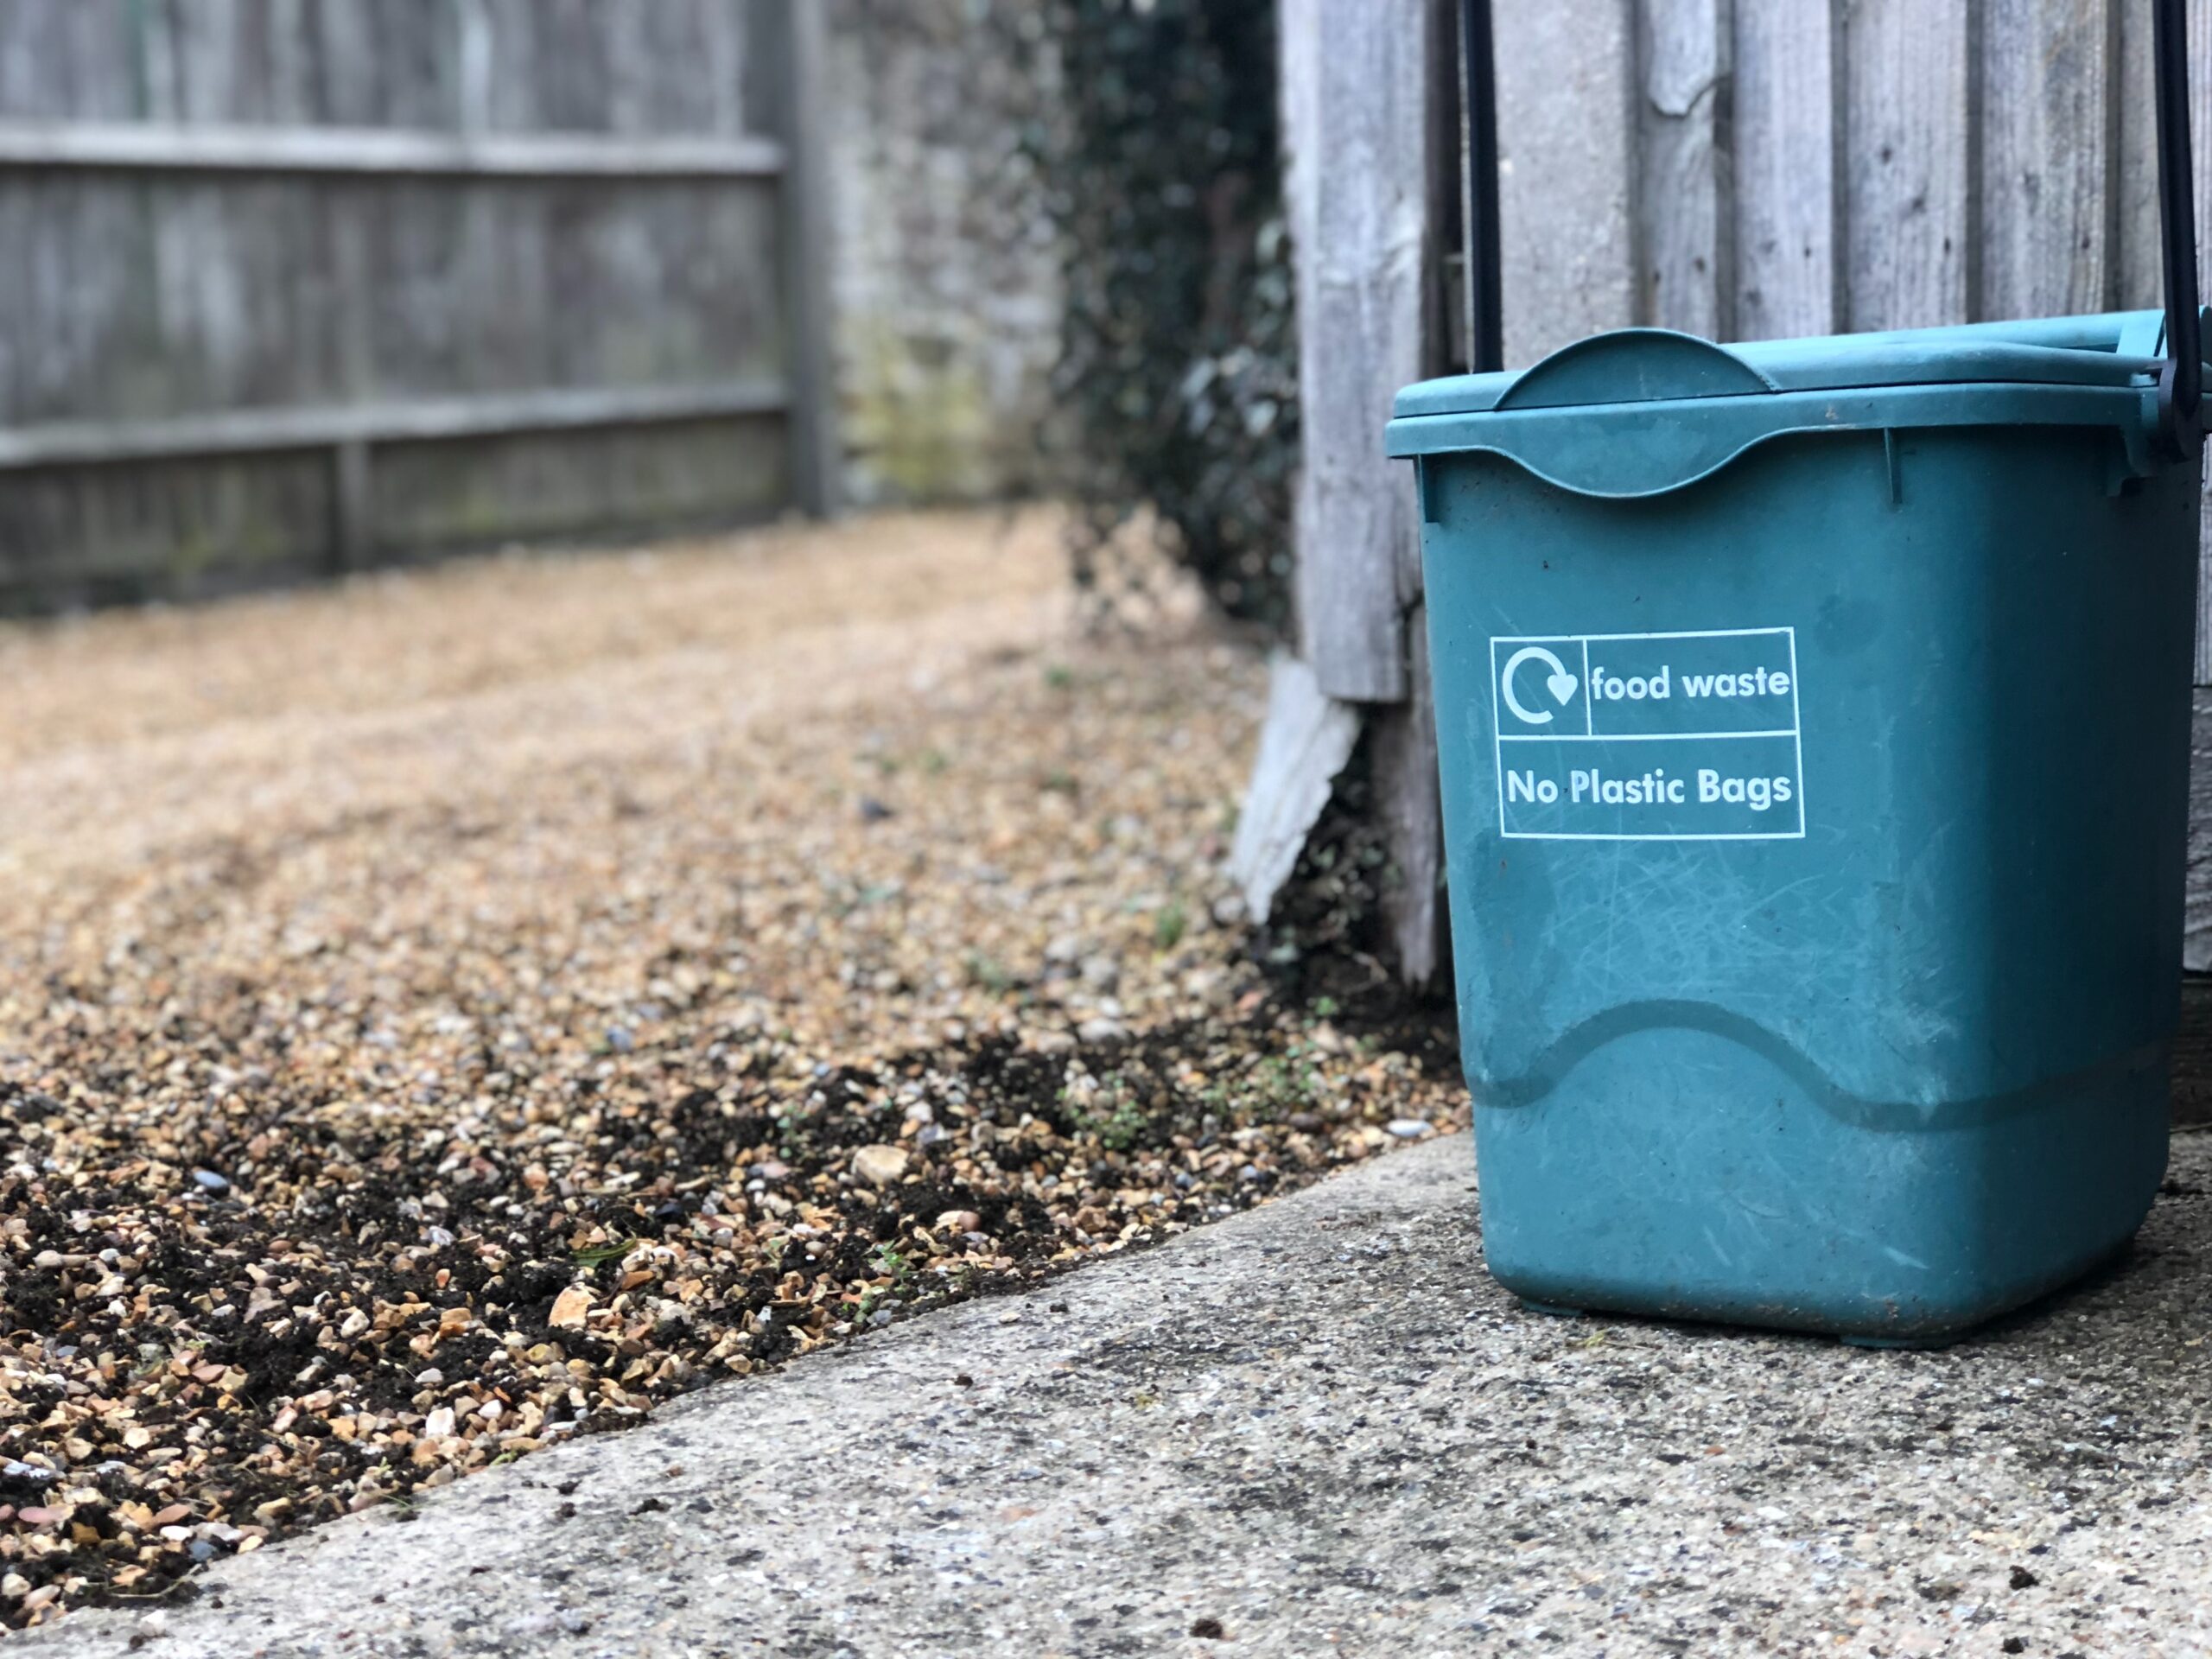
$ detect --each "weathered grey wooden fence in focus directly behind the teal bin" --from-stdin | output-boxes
[1263,0,2212,978]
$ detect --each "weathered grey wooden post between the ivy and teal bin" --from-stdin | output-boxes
[1248,0,1460,982]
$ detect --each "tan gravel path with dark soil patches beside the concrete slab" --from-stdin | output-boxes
[0,513,1462,1624]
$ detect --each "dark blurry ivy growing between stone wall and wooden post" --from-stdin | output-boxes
[995,0,1299,632]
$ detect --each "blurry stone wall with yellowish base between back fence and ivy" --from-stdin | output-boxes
[830,0,1059,506]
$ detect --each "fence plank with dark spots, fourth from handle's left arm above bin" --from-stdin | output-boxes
[1842,0,1978,329]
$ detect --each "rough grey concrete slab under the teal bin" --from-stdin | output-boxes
[26,1135,2212,1659]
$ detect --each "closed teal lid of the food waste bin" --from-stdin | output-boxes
[1387,312,2194,498]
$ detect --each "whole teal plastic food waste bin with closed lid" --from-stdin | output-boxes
[1389,315,2196,1343]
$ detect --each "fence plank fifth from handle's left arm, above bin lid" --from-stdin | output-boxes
[1975,0,2114,319]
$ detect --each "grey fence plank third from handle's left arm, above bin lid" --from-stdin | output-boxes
[1734,0,1842,340]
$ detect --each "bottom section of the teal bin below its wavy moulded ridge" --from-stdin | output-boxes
[1476,1027,2168,1347]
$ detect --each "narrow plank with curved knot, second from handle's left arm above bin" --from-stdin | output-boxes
[1637,0,1757,340]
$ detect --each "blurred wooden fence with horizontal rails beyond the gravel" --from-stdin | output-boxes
[0,0,834,606]
